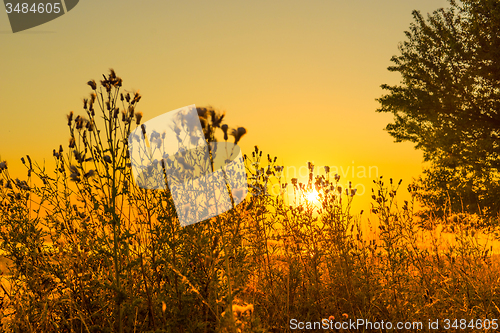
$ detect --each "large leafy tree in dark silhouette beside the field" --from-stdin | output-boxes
[377,0,500,222]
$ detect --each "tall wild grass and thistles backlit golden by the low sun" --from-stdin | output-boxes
[0,71,500,332]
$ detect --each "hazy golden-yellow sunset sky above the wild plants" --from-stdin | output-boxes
[0,0,454,210]
